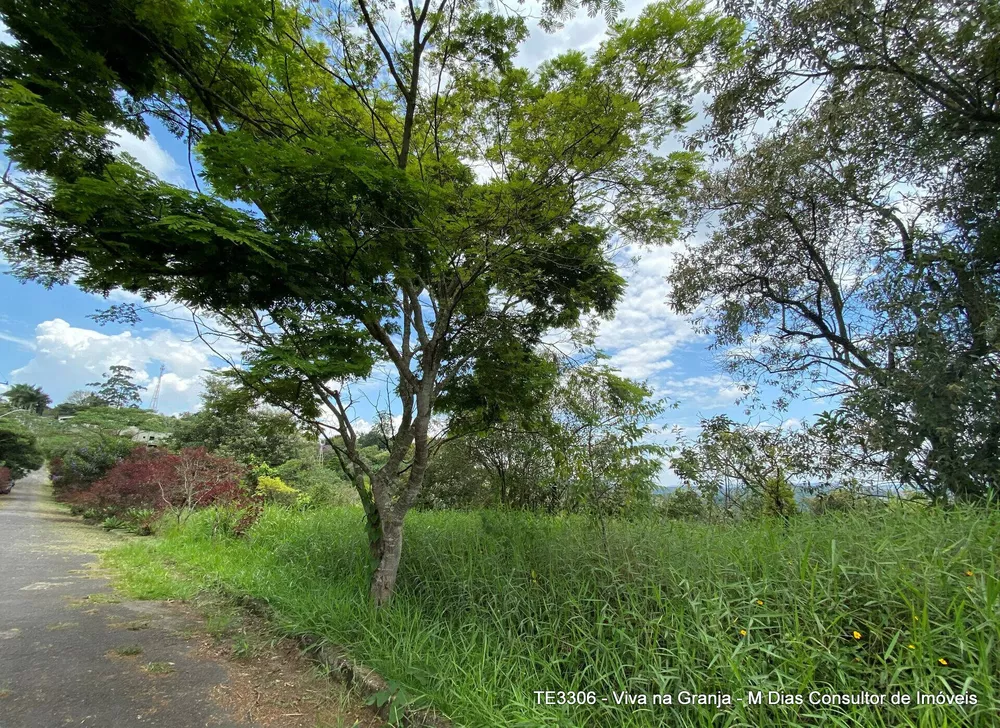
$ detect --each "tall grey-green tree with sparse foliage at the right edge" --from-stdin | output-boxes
[670,0,1000,498]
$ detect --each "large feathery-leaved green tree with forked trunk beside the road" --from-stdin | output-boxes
[0,0,739,603]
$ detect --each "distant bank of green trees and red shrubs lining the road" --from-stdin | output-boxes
[0,368,368,534]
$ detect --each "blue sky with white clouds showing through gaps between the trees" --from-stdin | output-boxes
[0,2,822,482]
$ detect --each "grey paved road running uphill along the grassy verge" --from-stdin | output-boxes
[0,471,252,728]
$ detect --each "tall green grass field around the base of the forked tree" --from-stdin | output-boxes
[108,508,1000,727]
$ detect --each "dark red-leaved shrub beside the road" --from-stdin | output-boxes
[73,447,246,514]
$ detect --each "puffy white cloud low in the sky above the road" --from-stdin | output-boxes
[10,318,216,414]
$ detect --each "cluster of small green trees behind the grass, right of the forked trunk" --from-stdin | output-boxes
[421,356,665,516]
